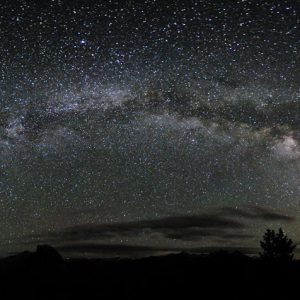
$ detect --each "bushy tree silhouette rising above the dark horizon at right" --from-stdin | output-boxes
[260,228,296,260]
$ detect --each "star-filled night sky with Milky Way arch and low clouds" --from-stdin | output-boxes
[0,0,300,257]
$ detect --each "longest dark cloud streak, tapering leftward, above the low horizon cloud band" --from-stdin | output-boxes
[27,214,245,241]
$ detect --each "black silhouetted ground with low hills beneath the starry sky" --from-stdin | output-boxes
[0,246,300,300]
